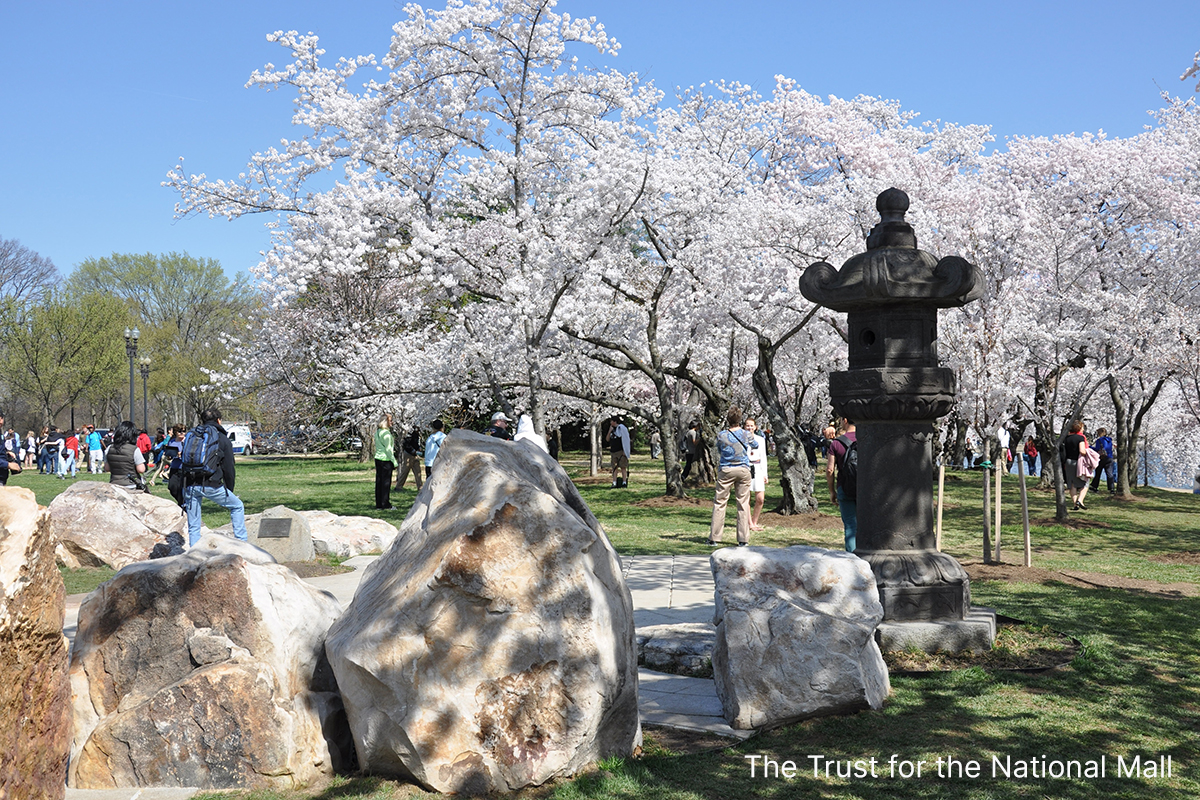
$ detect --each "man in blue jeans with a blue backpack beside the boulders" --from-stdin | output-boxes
[179,408,248,546]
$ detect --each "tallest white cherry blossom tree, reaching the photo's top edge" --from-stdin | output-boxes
[168,0,658,429]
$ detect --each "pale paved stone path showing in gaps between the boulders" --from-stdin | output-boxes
[64,555,751,800]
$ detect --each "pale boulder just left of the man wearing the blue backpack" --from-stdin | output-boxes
[49,481,187,570]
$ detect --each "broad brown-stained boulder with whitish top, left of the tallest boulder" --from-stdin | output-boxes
[68,535,353,789]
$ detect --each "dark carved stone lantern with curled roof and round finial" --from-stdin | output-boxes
[800,188,995,650]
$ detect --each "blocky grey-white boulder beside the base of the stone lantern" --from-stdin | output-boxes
[712,547,892,729]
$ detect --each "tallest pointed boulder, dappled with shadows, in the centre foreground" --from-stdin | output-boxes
[325,431,641,794]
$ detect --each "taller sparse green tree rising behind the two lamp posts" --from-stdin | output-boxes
[68,253,256,421]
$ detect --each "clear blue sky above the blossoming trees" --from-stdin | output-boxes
[0,0,1200,283]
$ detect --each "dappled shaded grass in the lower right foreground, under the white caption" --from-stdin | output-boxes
[556,583,1200,800]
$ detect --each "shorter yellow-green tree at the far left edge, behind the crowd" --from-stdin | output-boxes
[0,291,130,423]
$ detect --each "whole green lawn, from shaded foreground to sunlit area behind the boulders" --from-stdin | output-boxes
[30,453,1200,800]
